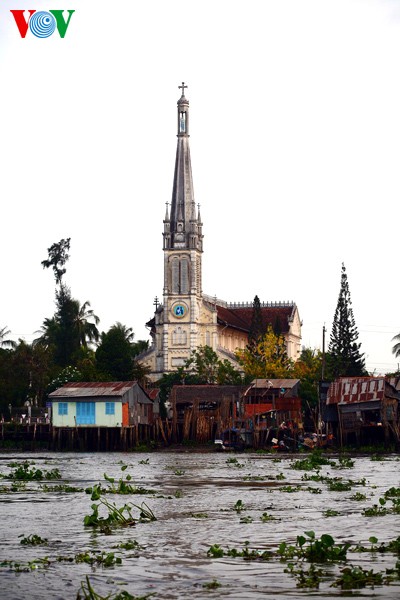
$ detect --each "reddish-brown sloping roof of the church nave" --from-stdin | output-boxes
[216,304,296,333]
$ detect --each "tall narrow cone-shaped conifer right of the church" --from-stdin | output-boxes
[328,263,366,378]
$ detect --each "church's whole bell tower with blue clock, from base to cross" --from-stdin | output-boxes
[157,82,203,372]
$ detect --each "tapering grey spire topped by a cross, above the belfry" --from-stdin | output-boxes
[165,82,202,250]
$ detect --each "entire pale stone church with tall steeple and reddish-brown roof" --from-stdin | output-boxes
[138,83,301,381]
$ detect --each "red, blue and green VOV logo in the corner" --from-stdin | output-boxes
[10,10,75,38]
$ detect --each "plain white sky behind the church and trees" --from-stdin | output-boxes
[0,0,400,373]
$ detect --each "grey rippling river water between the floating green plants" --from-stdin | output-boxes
[0,452,400,600]
